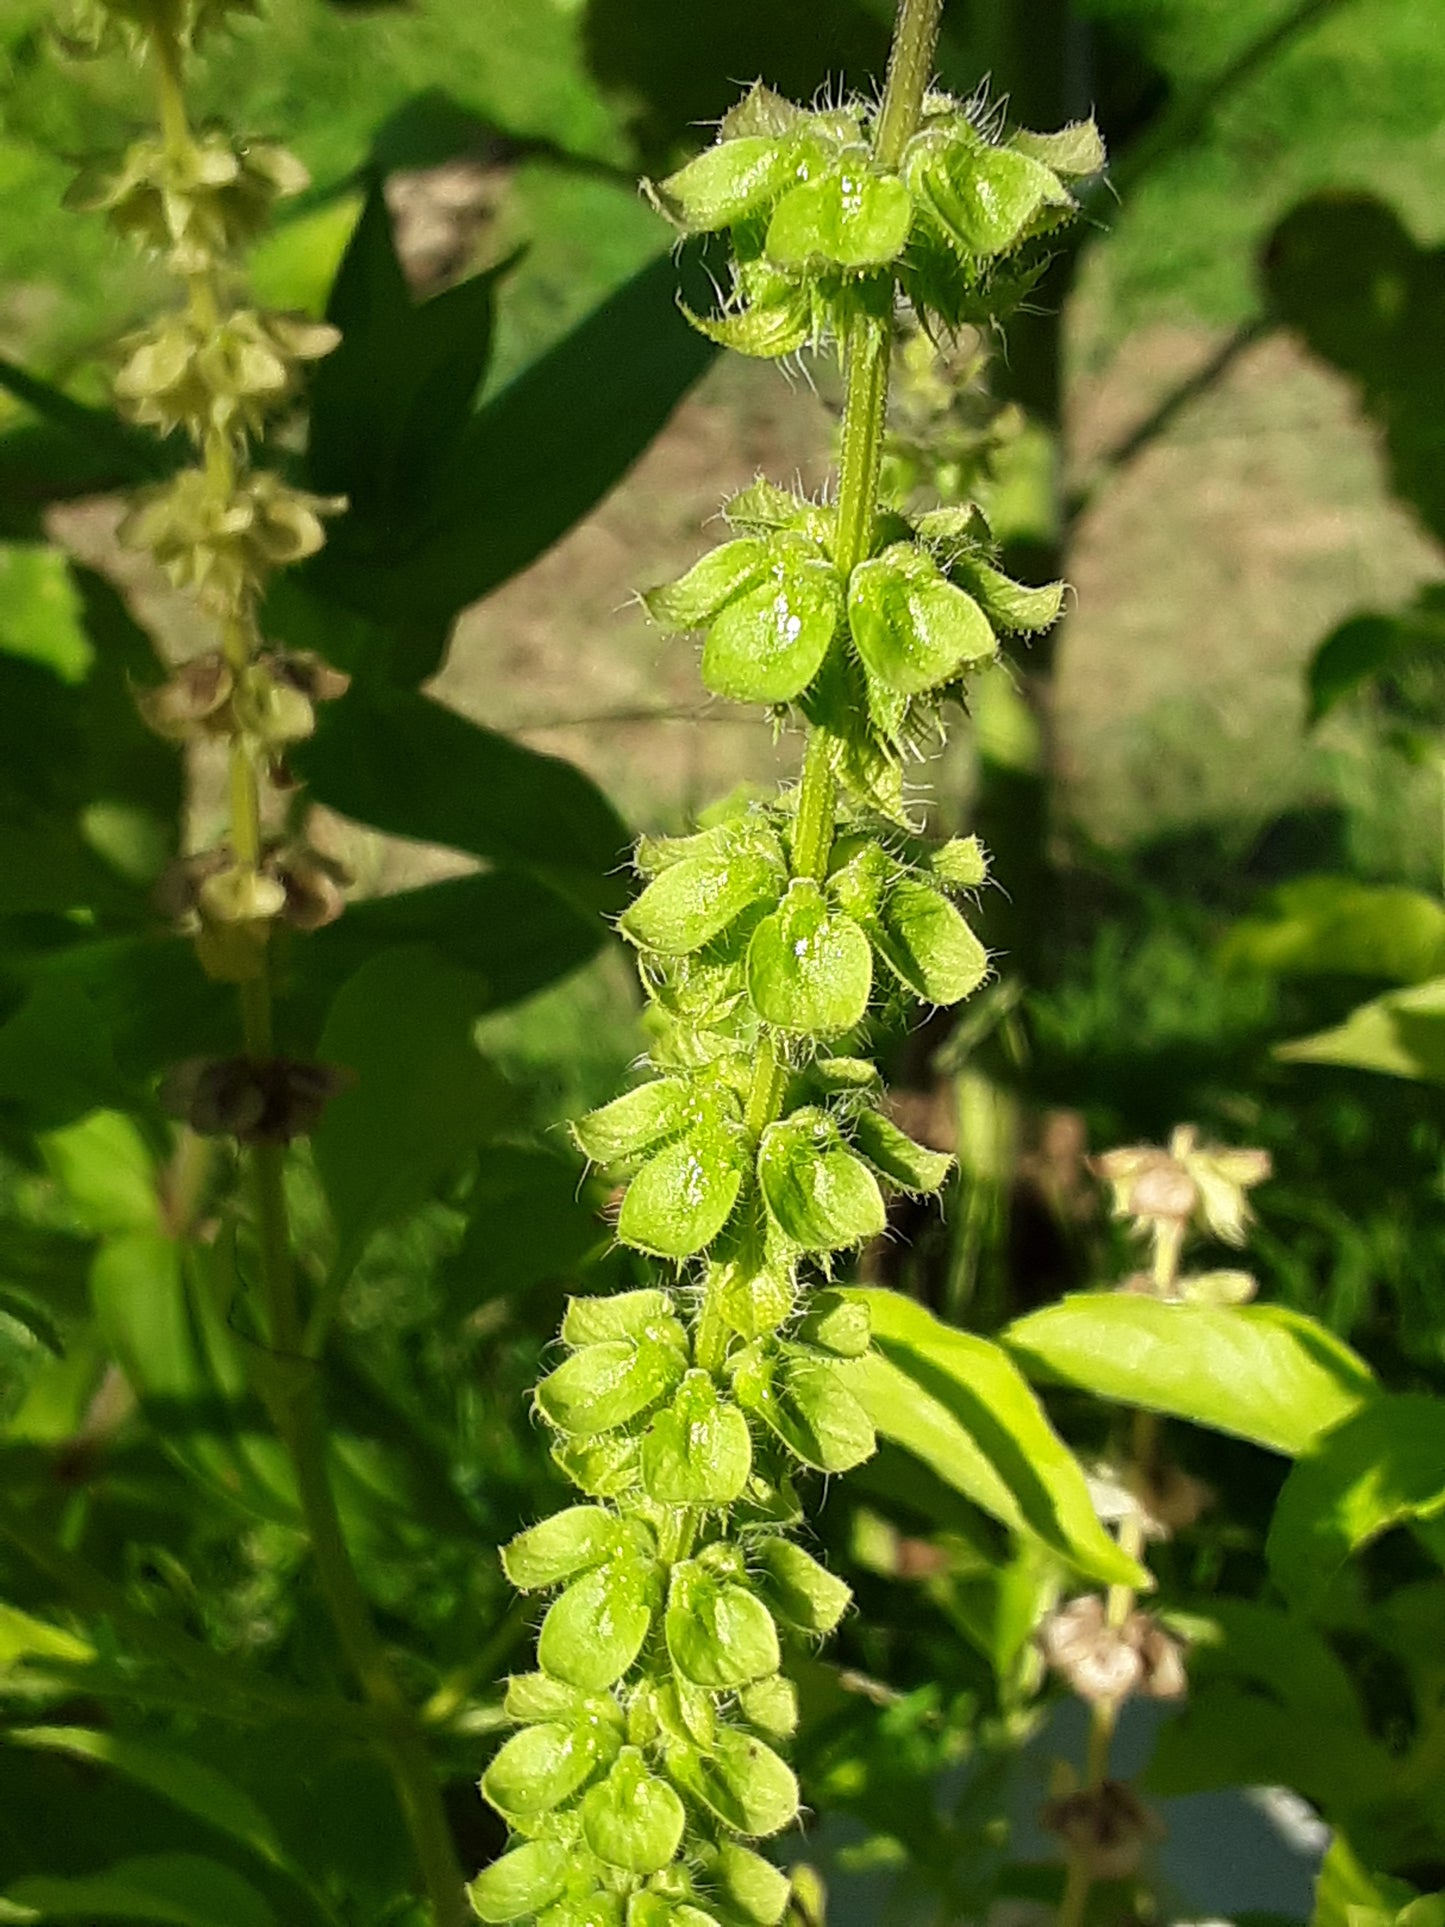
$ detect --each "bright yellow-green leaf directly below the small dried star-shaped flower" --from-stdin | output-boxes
[1004,1291,1376,1457]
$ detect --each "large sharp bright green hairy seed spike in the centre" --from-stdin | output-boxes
[481,71,1102,1927]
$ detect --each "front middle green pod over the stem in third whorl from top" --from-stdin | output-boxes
[748,877,873,1037]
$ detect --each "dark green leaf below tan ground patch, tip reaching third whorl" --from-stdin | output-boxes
[295,684,628,911]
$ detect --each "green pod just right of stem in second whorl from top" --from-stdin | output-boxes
[848,541,998,696]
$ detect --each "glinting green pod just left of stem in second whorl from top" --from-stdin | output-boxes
[703,532,844,703]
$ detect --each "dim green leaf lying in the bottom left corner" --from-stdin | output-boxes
[4,1854,276,1927]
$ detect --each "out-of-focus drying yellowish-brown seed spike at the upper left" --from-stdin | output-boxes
[69,0,347,1139]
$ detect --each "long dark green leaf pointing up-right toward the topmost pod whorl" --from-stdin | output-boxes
[306,247,715,622]
